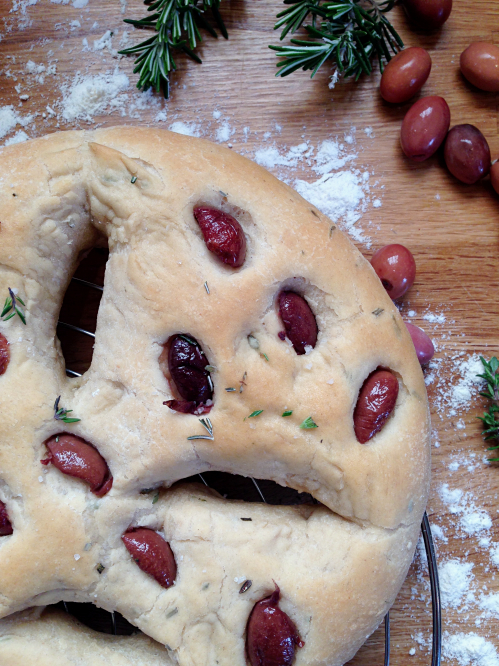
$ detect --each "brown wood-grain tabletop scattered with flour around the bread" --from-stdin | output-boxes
[0,0,499,666]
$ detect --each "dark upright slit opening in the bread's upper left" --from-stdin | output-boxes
[57,247,109,375]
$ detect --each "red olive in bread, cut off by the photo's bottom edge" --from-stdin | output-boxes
[246,585,305,666]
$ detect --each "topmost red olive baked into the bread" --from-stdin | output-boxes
[193,206,246,268]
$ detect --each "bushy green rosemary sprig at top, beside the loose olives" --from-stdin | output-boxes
[269,0,404,86]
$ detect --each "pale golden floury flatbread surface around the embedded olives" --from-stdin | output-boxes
[0,127,430,666]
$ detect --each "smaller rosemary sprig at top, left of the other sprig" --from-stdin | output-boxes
[119,0,229,98]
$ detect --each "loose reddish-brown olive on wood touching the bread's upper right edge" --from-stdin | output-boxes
[371,243,416,300]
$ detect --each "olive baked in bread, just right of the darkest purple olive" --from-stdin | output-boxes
[279,291,317,354]
